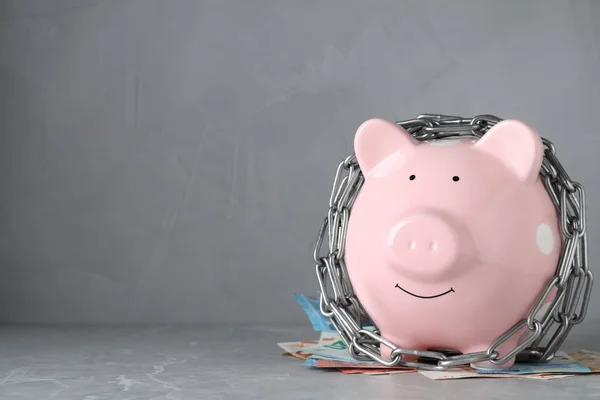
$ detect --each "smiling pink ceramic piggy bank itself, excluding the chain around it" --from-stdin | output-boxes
[345,119,562,368]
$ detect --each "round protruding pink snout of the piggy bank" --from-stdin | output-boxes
[389,212,461,282]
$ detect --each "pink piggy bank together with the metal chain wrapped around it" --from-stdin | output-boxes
[314,114,593,370]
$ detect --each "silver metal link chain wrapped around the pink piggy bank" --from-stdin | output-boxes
[313,114,593,370]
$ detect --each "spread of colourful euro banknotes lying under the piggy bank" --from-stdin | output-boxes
[278,294,600,380]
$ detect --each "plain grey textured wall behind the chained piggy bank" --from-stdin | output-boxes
[0,0,600,323]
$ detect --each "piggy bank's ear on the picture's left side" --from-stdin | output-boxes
[354,118,417,176]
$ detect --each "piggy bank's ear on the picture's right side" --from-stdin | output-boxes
[474,120,544,182]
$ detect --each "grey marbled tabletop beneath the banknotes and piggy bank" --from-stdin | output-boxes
[0,321,600,400]
